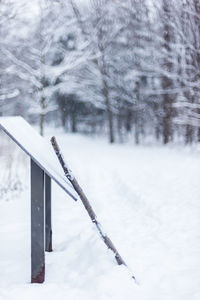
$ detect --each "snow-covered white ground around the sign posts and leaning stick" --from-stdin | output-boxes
[0,134,200,300]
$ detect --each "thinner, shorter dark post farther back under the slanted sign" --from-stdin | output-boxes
[45,173,52,252]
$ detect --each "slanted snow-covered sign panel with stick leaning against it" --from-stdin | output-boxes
[0,117,77,200]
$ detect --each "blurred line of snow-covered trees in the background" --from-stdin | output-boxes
[0,0,200,144]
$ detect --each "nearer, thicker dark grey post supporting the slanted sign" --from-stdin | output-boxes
[31,159,45,283]
